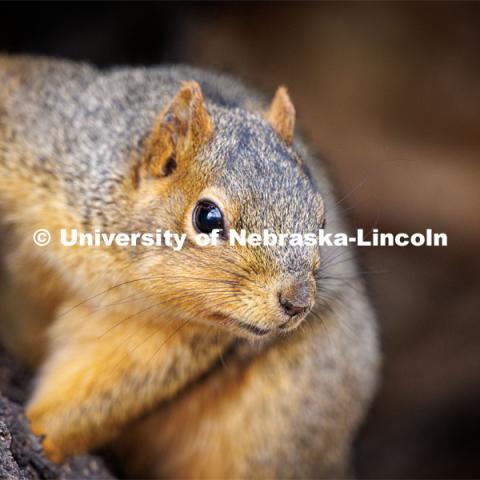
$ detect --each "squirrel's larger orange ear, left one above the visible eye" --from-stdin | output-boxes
[146,81,213,177]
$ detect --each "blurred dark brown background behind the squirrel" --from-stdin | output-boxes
[0,2,480,478]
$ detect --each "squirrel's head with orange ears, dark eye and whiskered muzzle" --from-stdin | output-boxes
[124,81,324,336]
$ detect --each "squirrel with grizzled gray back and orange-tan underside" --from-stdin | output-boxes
[0,55,379,478]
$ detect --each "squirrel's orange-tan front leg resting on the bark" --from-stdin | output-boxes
[27,302,229,462]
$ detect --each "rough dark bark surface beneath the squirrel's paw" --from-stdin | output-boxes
[0,347,114,480]
